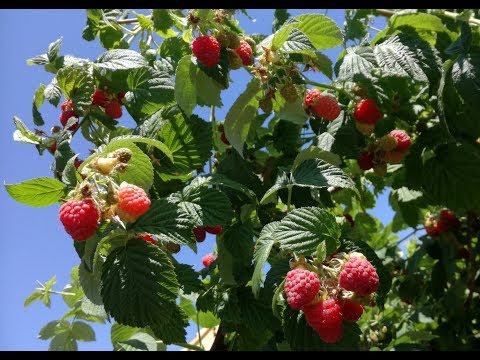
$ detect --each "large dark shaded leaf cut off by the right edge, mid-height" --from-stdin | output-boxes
[422,144,480,212]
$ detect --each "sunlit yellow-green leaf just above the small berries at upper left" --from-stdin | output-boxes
[57,66,95,115]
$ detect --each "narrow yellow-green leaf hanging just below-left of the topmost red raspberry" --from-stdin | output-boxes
[175,55,198,116]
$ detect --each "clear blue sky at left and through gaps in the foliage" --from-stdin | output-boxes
[0,9,402,350]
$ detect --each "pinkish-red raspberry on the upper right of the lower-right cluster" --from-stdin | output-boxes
[339,256,378,296]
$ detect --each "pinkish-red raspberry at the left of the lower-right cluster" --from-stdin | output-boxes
[285,269,320,310]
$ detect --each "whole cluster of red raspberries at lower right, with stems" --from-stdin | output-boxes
[284,252,379,343]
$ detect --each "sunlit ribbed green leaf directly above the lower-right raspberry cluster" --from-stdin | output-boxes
[273,207,341,256]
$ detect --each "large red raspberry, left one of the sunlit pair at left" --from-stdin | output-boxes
[59,199,100,241]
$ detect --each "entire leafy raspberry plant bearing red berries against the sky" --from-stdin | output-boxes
[6,9,480,350]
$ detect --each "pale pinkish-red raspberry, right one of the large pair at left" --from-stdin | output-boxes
[117,182,150,222]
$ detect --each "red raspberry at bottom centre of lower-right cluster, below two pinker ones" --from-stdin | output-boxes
[303,298,343,331]
